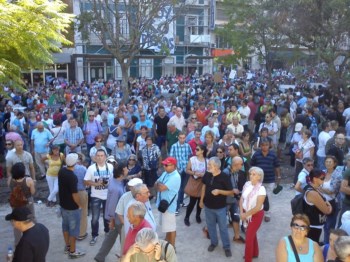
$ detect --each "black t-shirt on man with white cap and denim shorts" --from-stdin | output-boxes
[58,167,79,210]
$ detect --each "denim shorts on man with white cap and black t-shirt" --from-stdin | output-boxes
[61,208,81,237]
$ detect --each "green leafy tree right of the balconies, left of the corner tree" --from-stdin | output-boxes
[217,0,286,81]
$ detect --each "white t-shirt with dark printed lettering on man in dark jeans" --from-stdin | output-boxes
[84,164,113,200]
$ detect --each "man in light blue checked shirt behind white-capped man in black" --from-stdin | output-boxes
[64,117,84,154]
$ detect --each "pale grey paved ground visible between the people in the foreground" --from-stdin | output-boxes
[0,184,294,262]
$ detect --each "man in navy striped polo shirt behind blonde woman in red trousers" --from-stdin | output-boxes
[250,138,281,222]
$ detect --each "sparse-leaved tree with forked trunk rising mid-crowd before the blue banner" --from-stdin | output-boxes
[78,0,185,101]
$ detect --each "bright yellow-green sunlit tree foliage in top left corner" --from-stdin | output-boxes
[0,0,73,87]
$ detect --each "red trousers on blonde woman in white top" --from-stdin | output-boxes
[244,210,264,262]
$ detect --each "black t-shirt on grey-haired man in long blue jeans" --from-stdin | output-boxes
[202,172,233,209]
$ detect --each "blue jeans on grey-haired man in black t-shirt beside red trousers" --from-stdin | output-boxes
[205,207,231,250]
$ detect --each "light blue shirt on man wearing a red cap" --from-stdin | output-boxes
[156,170,181,213]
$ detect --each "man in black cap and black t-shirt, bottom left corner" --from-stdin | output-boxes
[5,207,50,262]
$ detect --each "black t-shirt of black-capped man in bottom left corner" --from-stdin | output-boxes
[13,223,50,262]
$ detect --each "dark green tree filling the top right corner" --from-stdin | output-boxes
[280,0,350,92]
